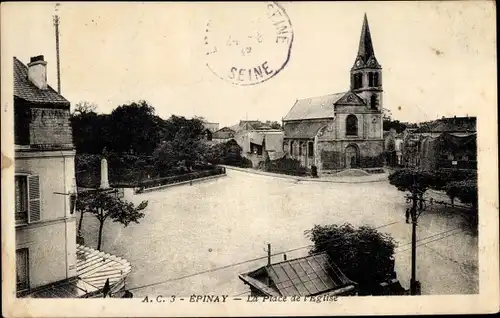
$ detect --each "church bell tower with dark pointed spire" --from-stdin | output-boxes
[351,14,383,112]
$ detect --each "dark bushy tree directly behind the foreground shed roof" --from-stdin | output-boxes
[305,223,396,294]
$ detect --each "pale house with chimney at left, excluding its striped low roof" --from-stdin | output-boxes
[14,56,77,293]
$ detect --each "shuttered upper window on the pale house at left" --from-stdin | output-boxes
[15,175,41,225]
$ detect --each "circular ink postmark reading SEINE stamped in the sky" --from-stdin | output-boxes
[205,2,293,85]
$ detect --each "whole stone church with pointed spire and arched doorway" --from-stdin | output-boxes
[283,14,384,172]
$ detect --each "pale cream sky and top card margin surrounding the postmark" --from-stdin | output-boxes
[1,1,496,127]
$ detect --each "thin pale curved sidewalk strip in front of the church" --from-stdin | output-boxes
[221,165,388,183]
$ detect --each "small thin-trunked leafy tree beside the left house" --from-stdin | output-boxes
[76,190,148,250]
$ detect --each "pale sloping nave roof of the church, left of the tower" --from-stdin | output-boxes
[283,93,346,121]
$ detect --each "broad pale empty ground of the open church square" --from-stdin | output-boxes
[78,170,478,297]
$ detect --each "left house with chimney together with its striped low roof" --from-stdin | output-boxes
[14,56,131,298]
